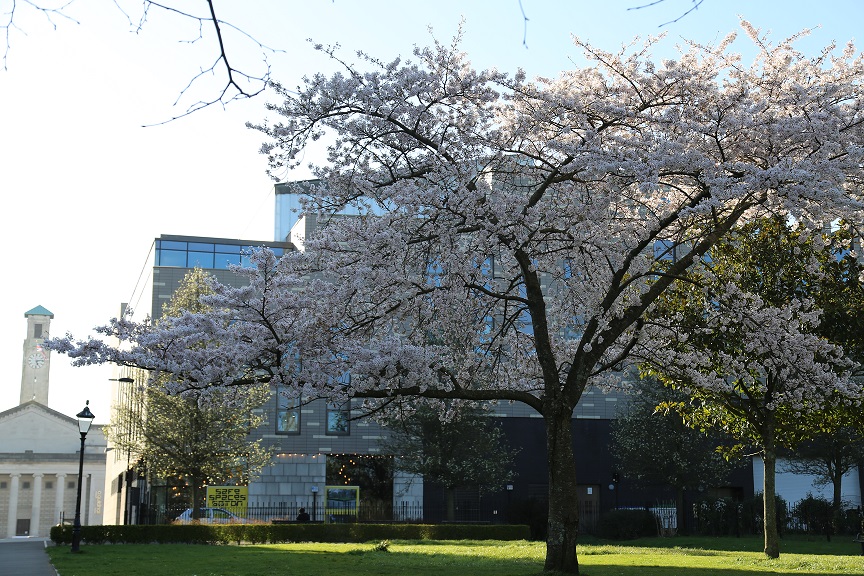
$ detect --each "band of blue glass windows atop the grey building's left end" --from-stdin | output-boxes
[156,238,285,270]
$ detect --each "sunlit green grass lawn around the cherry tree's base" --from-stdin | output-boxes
[48,537,864,576]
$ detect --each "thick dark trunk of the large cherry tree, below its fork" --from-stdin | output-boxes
[544,410,579,574]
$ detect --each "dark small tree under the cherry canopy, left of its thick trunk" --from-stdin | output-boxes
[382,402,515,520]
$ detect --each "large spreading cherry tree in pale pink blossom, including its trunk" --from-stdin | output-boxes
[52,23,864,573]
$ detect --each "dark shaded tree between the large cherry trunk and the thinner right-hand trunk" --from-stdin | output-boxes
[611,381,732,530]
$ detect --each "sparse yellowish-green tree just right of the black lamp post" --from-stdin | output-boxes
[107,268,272,518]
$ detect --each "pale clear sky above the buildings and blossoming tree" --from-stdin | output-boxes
[0,0,864,422]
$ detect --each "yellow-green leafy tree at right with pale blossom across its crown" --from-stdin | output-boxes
[649,216,861,557]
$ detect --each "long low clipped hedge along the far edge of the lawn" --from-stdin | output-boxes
[51,524,531,545]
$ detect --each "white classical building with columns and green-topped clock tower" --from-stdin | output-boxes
[0,306,106,538]
